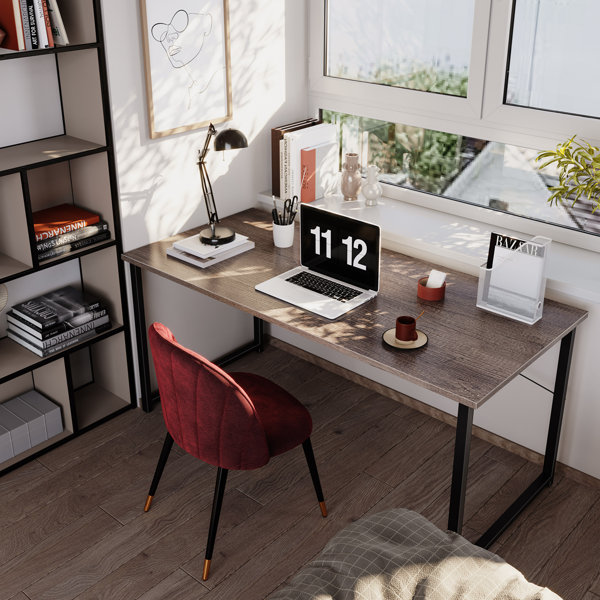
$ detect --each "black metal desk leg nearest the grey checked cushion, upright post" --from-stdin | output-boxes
[448,404,473,533]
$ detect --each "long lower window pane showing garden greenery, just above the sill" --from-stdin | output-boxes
[322,111,600,234]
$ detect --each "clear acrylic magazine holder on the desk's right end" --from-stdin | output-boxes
[477,236,552,325]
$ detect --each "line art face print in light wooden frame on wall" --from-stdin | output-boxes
[140,0,232,138]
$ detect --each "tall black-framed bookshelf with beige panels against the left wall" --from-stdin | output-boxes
[0,0,135,475]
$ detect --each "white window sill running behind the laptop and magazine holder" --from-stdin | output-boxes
[257,192,600,304]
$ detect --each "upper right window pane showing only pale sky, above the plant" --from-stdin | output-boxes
[504,0,600,117]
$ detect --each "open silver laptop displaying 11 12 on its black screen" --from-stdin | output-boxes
[255,204,381,319]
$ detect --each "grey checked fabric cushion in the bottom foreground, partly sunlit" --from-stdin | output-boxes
[268,509,560,600]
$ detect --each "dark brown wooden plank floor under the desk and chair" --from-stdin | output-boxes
[0,347,600,600]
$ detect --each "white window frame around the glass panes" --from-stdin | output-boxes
[308,0,600,252]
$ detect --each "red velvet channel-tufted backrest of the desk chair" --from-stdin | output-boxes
[148,323,269,469]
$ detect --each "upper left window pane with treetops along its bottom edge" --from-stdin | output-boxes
[325,0,475,97]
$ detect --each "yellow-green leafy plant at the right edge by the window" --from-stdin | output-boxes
[536,135,600,214]
